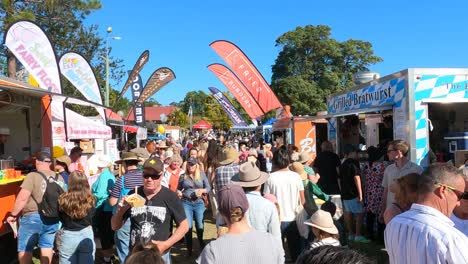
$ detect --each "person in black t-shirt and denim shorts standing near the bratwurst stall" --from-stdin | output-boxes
[338,145,369,243]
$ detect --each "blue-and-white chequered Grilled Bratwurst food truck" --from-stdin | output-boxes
[312,68,468,167]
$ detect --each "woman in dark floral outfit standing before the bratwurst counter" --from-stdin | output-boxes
[363,147,387,241]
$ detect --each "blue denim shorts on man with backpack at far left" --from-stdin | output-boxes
[18,213,59,252]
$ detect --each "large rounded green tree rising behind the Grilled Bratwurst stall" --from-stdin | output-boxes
[271,25,382,115]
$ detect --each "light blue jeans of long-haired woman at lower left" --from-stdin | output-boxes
[58,226,96,264]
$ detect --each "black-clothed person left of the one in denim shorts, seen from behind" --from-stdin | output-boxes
[313,141,341,194]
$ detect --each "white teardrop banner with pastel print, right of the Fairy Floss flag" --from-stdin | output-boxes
[59,52,106,119]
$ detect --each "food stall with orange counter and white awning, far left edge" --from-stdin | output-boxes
[0,78,111,237]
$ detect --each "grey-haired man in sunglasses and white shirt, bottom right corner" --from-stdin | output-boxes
[385,164,468,264]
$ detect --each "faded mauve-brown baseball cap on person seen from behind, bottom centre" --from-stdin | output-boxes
[218,184,249,216]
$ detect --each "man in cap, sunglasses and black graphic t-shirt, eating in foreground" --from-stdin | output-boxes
[112,158,188,263]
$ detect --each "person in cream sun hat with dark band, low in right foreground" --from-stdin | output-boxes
[304,209,340,249]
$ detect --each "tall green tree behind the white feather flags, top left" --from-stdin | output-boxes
[0,0,128,114]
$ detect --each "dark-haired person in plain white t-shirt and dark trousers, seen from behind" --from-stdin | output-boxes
[264,146,305,262]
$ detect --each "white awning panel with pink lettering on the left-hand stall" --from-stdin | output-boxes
[52,108,112,140]
